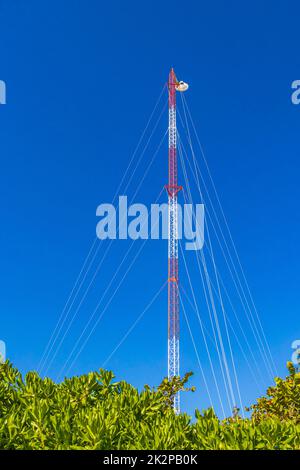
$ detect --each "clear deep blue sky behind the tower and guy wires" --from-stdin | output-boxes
[0,0,300,418]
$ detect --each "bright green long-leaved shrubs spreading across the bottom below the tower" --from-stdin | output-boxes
[0,362,300,450]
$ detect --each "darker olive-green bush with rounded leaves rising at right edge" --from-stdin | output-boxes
[250,362,300,424]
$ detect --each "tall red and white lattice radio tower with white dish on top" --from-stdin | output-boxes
[166,68,188,413]
